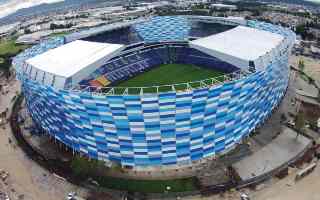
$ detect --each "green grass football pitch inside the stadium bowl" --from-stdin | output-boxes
[117,64,224,87]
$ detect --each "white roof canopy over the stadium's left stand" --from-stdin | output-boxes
[26,40,124,88]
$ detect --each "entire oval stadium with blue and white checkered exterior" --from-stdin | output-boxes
[13,16,295,167]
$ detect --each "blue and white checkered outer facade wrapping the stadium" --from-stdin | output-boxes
[15,19,296,166]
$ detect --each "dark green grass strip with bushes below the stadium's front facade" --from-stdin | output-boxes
[70,156,198,193]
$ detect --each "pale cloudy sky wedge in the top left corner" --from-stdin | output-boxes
[0,0,64,18]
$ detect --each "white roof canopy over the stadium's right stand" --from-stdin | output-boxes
[190,26,284,68]
